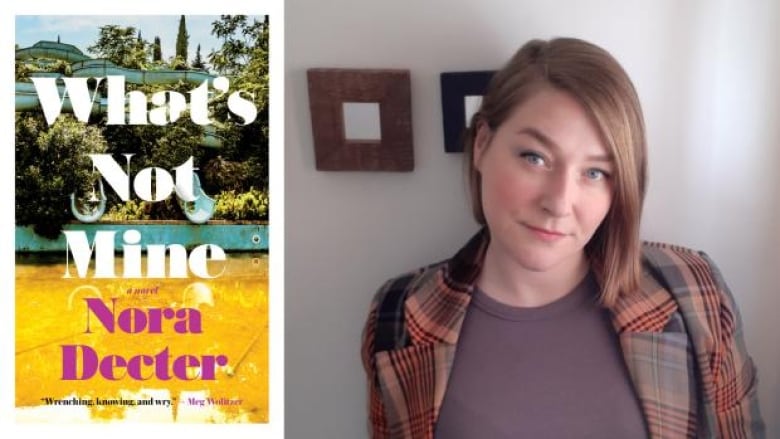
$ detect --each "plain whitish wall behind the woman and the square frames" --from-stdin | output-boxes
[285,0,780,439]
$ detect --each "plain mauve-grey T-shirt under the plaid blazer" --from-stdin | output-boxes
[435,274,647,439]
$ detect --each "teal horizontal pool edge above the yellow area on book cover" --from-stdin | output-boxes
[15,221,268,253]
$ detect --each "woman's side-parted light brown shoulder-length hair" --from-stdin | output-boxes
[464,38,647,307]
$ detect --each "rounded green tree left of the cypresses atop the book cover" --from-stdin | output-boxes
[87,24,147,69]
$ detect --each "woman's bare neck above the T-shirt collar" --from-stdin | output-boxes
[477,242,589,307]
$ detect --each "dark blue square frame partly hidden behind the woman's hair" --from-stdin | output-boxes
[441,70,495,152]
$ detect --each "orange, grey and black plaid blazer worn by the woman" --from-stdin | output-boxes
[362,230,764,439]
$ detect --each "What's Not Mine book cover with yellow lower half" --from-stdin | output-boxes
[14,15,274,424]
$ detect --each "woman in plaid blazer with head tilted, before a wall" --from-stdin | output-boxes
[362,38,763,439]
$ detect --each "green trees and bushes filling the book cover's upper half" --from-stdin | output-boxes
[16,16,268,236]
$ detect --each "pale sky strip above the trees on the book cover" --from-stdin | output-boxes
[15,15,232,68]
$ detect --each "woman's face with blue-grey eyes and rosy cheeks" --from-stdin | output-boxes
[474,86,613,272]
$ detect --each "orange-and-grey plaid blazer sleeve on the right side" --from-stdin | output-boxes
[643,248,765,437]
